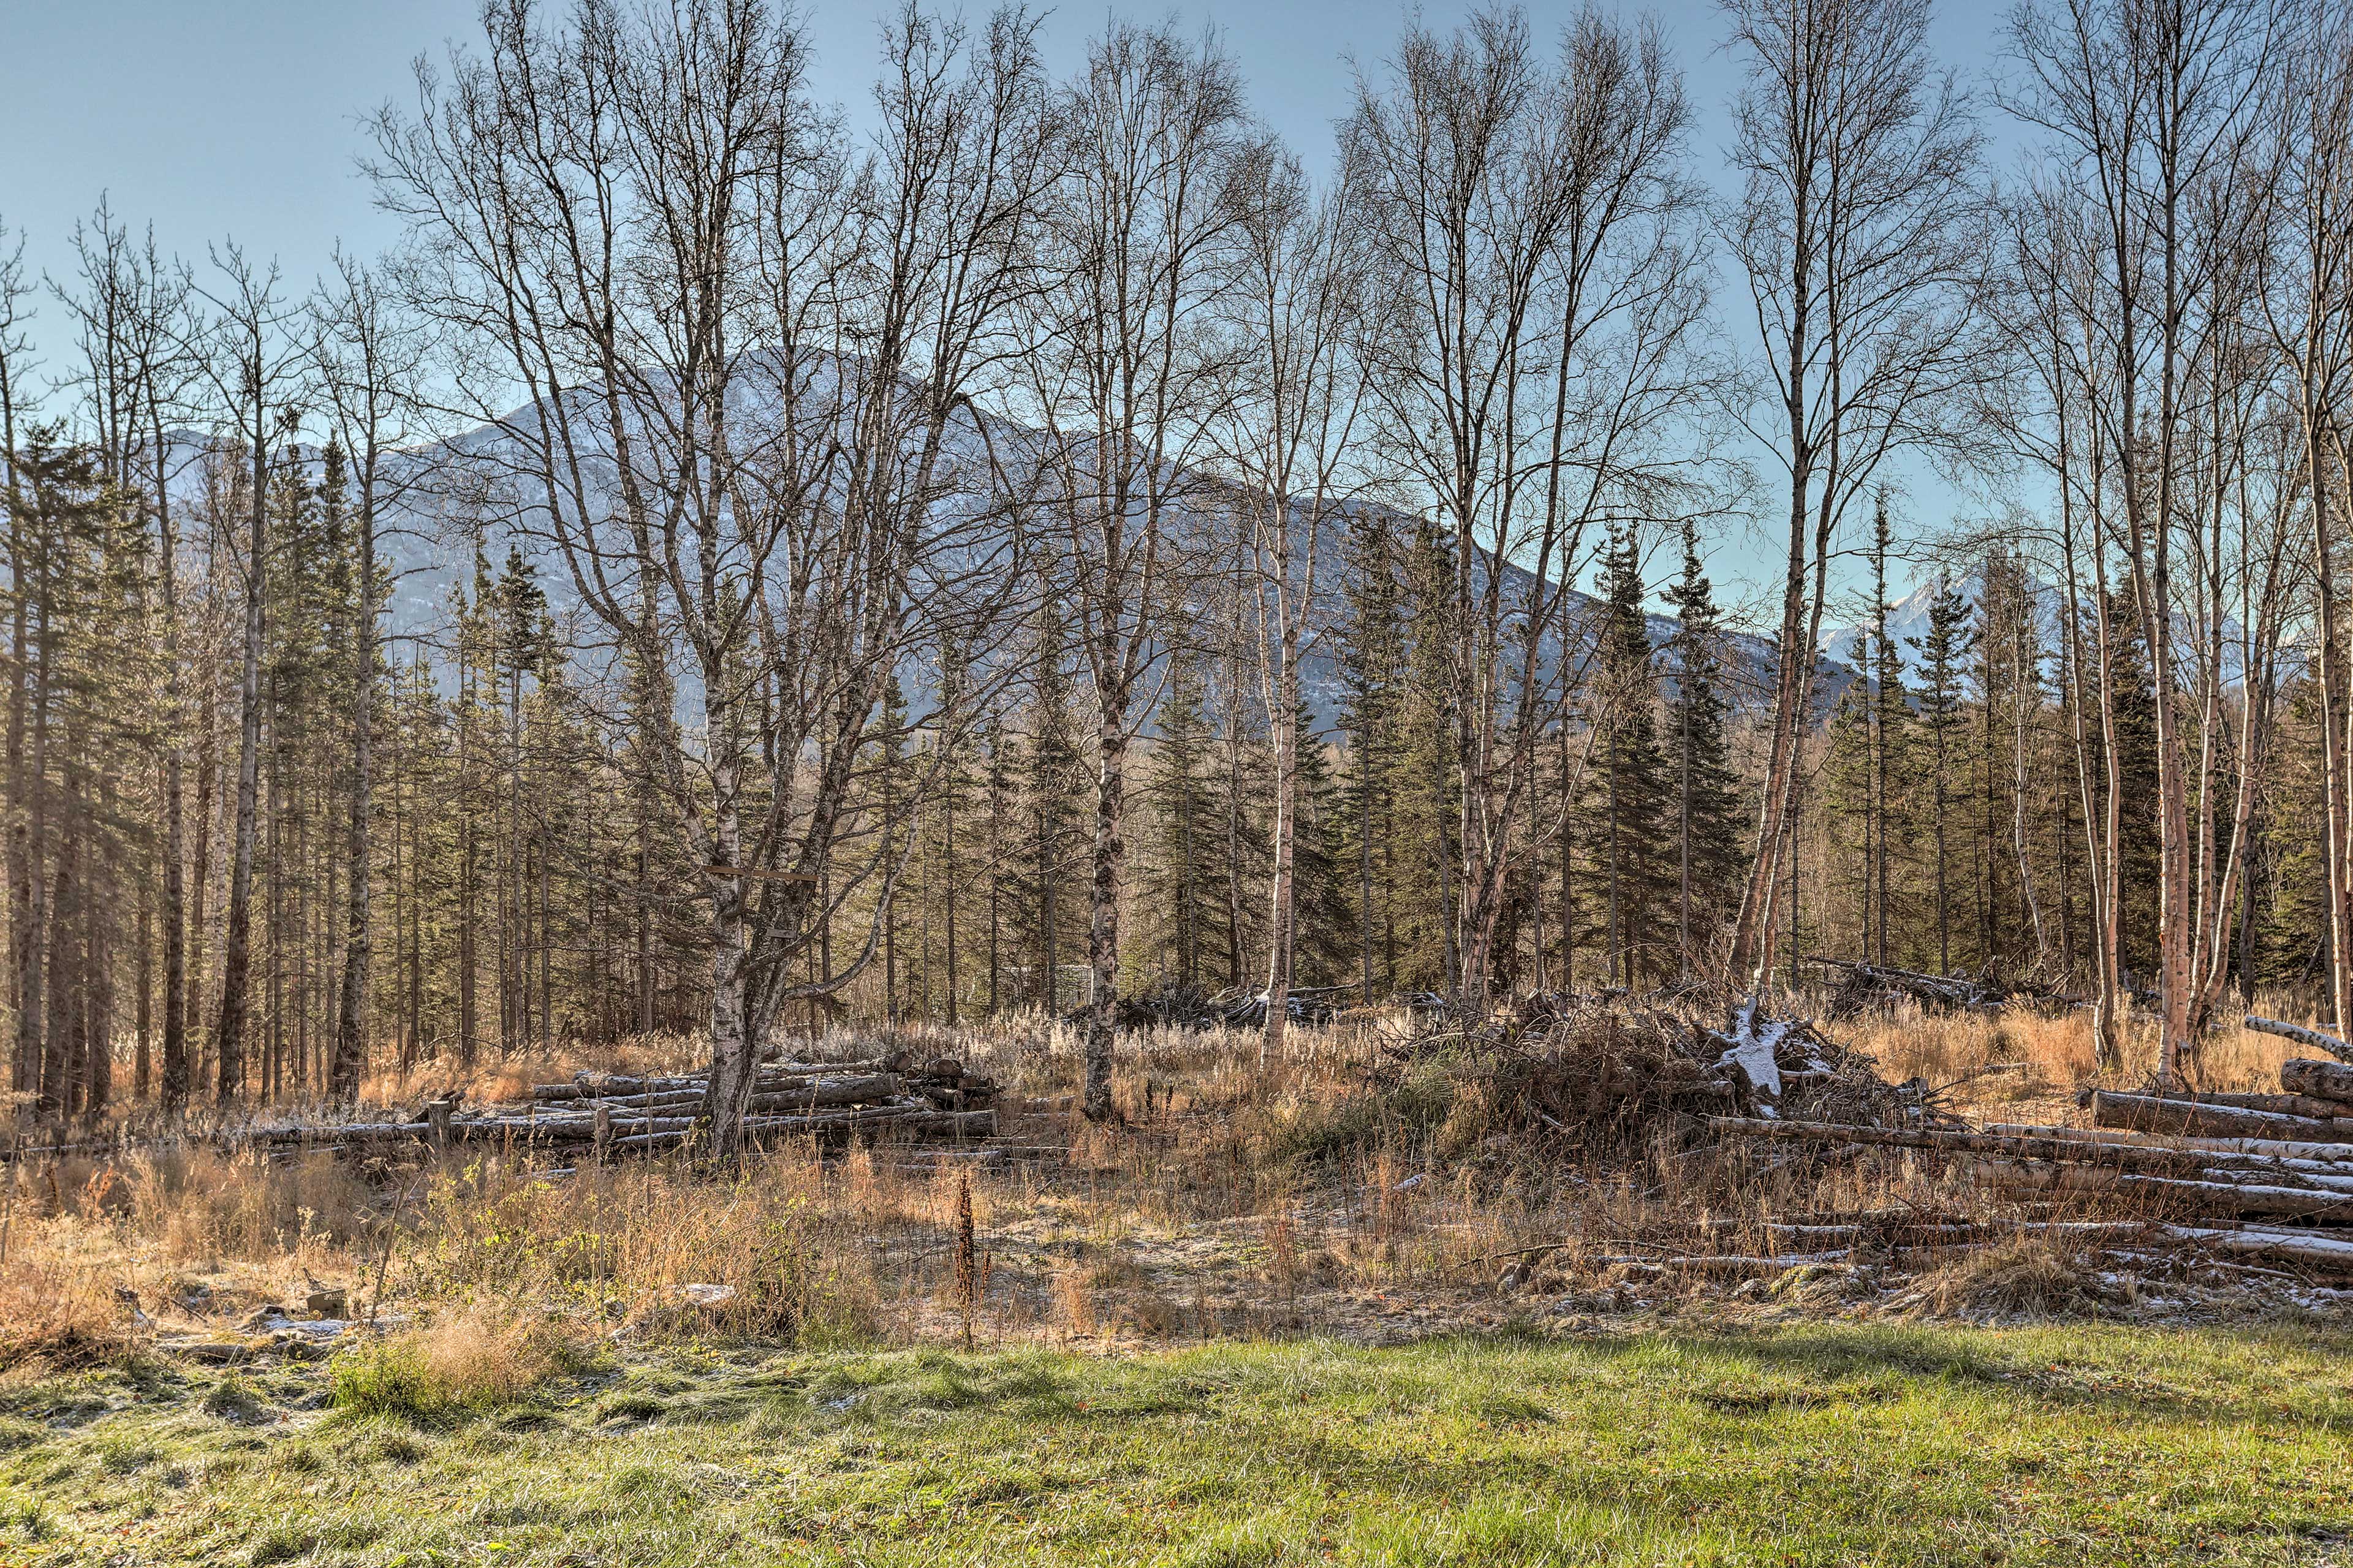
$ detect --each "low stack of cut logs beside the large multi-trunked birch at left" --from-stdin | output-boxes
[247,1057,998,1156]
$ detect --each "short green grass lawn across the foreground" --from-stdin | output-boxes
[0,1325,2353,1568]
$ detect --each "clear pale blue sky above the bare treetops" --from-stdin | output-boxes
[0,0,2000,612]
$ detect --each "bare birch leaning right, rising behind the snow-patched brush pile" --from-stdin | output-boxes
[1722,0,1988,987]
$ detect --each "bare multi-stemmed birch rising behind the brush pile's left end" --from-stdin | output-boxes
[1344,9,1703,1001]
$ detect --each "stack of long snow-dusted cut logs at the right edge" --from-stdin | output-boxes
[1713,1017,2353,1271]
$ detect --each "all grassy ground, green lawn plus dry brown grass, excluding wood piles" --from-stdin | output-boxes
[0,1015,2353,1568]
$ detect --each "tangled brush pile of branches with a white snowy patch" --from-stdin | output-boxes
[1372,993,1949,1140]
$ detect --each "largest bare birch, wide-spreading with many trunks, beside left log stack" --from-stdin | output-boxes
[374,0,1051,1156]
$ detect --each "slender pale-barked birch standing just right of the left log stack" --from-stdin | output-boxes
[1023,23,1249,1121]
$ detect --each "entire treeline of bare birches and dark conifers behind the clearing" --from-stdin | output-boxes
[0,0,2353,1151]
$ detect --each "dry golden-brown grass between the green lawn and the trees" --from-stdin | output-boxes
[0,1010,2334,1356]
